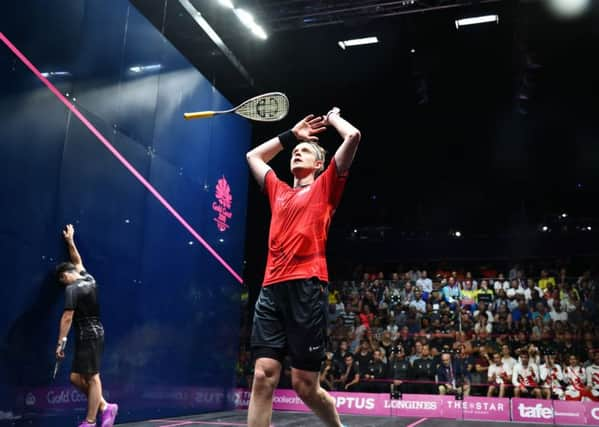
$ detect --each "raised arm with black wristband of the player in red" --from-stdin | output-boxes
[245,114,326,187]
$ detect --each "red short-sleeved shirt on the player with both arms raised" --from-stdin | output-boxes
[263,158,346,286]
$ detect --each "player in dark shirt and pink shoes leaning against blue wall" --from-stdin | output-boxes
[56,224,118,427]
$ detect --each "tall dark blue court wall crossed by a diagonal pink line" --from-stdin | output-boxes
[0,0,250,426]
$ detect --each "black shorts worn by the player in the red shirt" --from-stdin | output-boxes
[251,278,328,372]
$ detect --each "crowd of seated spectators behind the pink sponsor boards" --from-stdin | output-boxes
[238,266,599,401]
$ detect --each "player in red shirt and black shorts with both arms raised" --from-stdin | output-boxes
[247,108,361,427]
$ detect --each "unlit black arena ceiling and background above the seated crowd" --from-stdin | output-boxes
[131,0,599,272]
